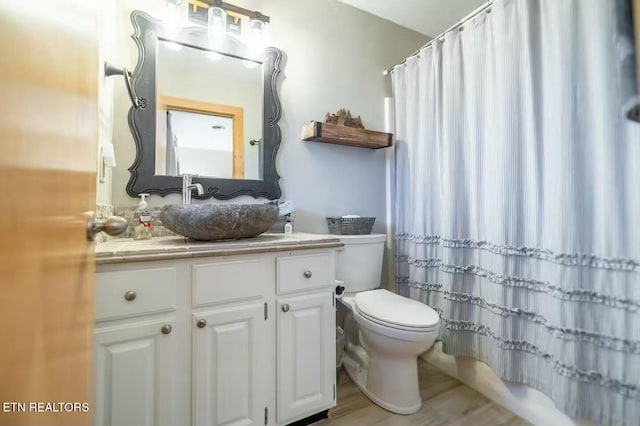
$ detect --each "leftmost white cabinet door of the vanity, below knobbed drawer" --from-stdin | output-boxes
[94,317,179,426]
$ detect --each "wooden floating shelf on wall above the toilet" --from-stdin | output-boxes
[302,121,395,149]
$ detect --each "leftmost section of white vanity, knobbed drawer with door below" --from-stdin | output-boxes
[93,263,187,426]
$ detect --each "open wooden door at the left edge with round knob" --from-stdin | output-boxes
[0,0,99,425]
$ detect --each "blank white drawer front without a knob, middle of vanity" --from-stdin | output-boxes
[192,259,274,307]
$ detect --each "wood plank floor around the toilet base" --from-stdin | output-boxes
[315,359,530,426]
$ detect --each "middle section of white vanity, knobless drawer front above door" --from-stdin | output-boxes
[191,256,276,426]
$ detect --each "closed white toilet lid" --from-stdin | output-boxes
[356,289,440,330]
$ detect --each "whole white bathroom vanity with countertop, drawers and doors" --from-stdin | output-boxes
[93,234,342,426]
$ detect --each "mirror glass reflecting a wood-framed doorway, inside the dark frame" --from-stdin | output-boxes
[156,39,263,180]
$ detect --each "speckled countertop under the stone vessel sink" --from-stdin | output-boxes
[96,233,342,265]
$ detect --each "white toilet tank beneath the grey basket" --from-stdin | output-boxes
[333,234,387,293]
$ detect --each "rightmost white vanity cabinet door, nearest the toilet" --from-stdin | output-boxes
[278,291,336,424]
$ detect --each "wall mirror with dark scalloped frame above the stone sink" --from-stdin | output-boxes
[127,11,281,199]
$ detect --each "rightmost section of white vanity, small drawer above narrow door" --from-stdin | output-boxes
[277,253,336,424]
